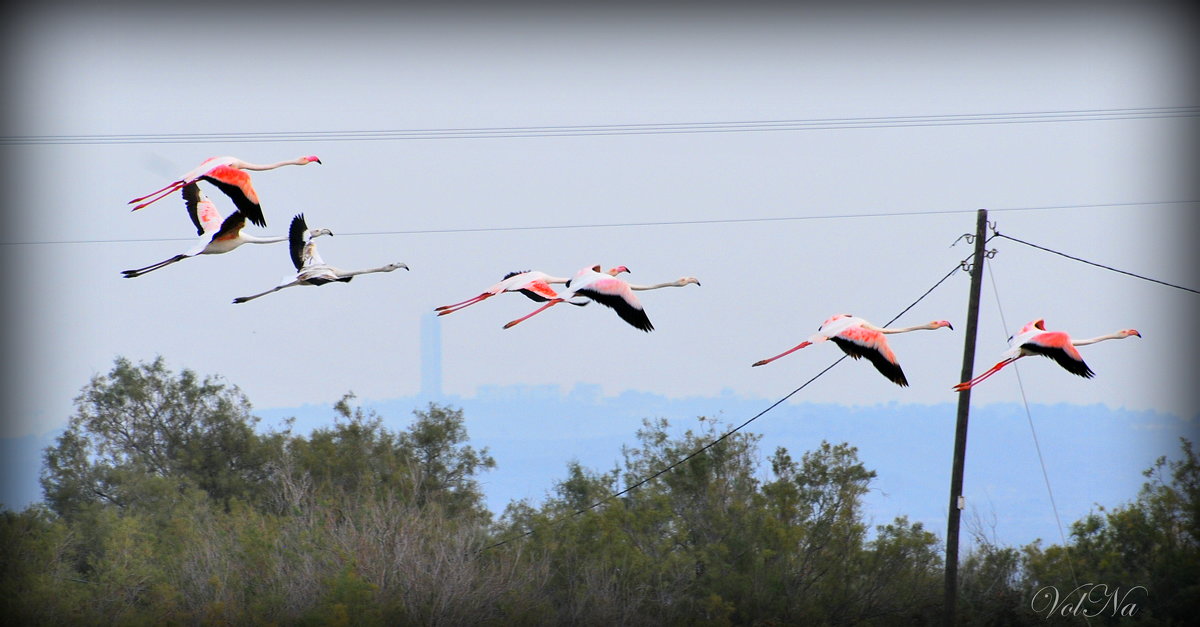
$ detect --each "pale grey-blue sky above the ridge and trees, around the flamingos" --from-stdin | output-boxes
[0,2,1200,530]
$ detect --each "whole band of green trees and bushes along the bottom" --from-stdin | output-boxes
[0,359,1200,625]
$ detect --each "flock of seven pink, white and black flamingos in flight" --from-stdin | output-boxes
[121,155,1141,392]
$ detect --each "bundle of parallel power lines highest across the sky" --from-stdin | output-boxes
[0,106,1200,145]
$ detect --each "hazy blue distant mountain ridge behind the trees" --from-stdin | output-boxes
[9,384,1200,545]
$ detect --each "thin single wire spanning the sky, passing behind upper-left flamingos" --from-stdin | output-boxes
[7,201,1200,246]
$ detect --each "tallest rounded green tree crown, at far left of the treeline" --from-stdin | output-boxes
[42,357,278,518]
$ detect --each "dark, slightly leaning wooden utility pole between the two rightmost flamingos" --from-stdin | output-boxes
[943,209,988,627]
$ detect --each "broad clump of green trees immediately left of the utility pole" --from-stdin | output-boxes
[504,418,938,625]
